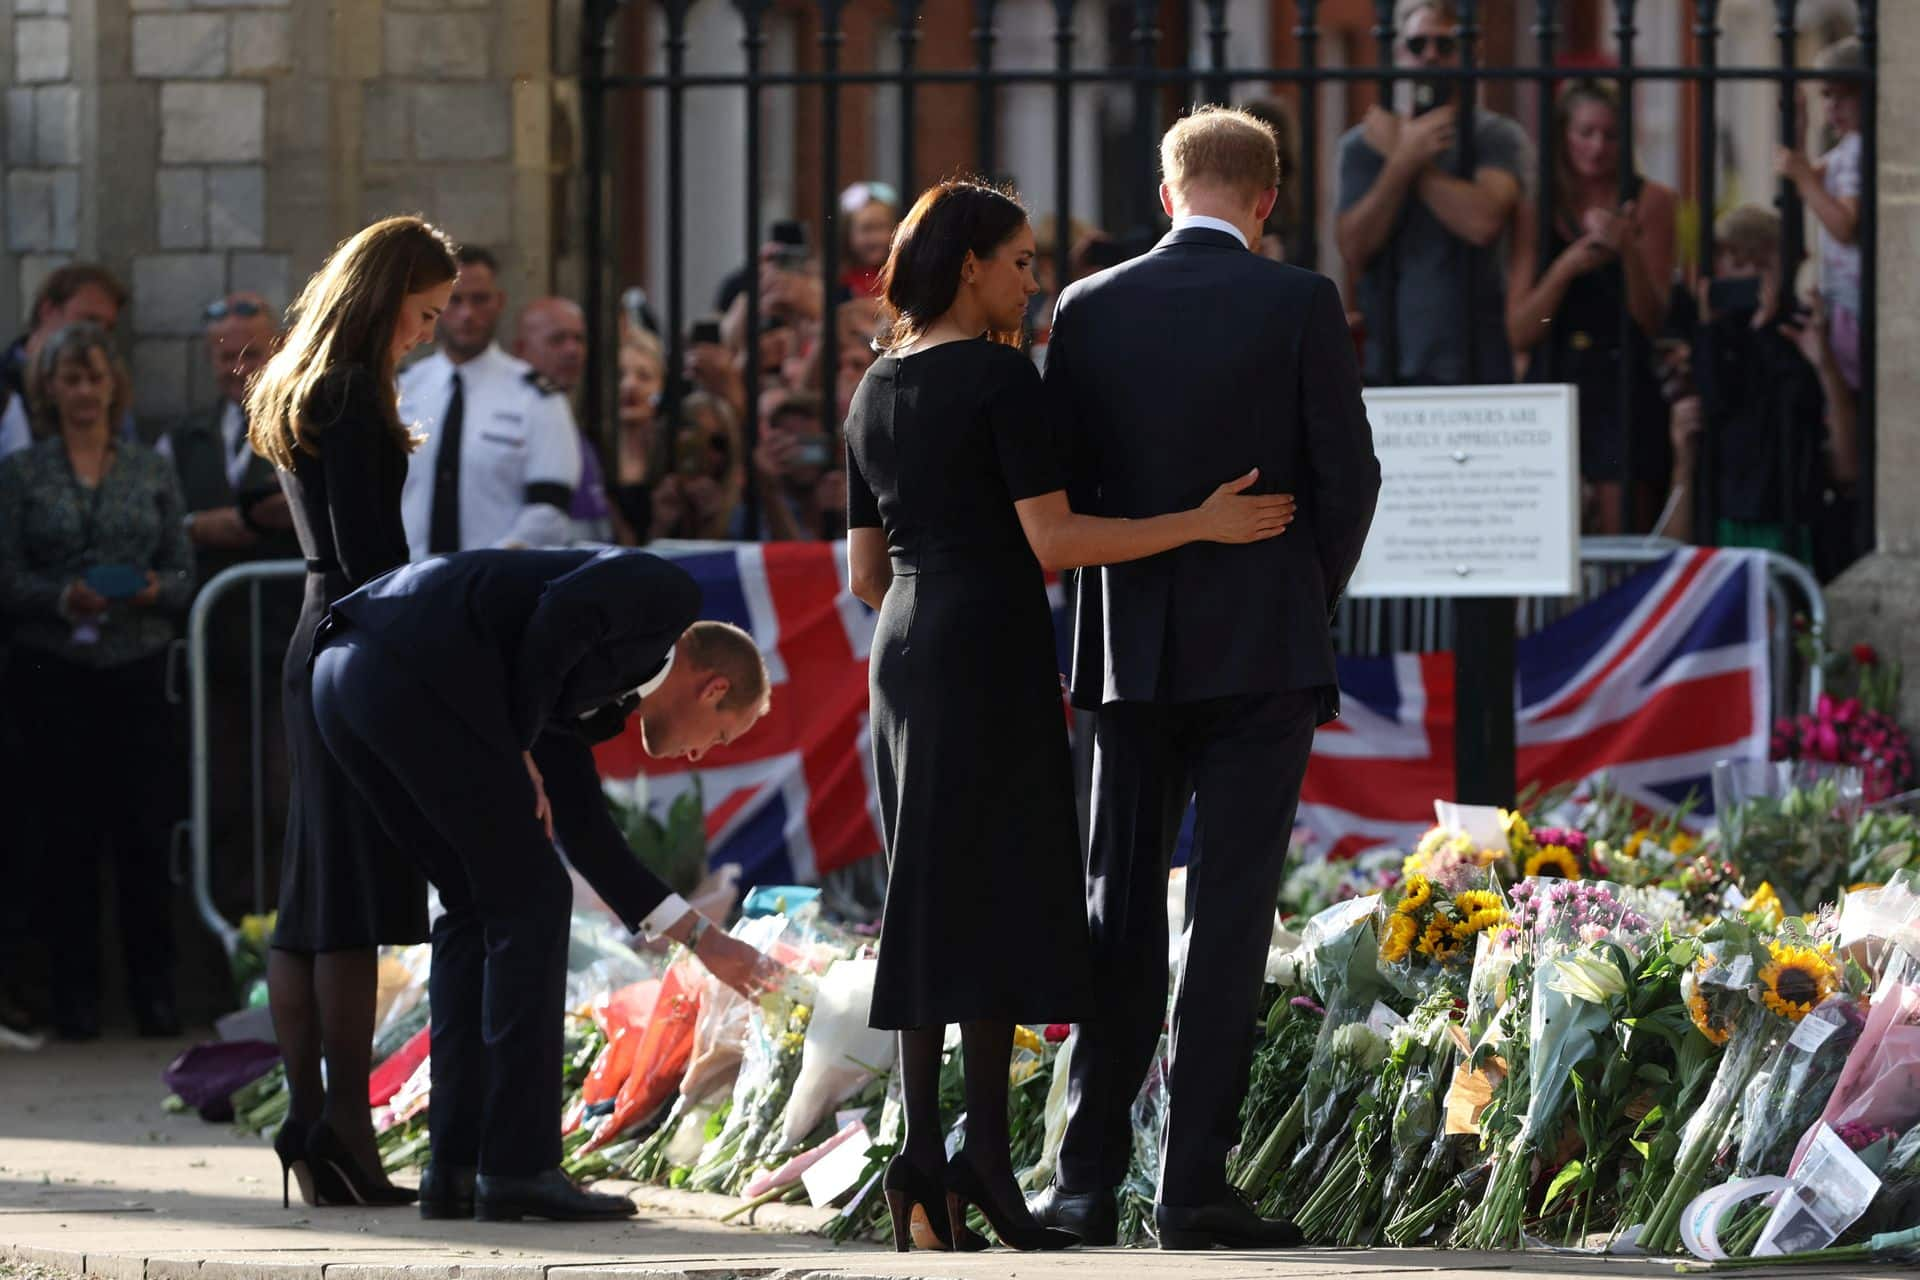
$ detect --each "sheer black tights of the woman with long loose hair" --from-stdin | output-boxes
[267,946,393,1178]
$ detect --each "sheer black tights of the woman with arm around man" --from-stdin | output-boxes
[900,1021,1027,1221]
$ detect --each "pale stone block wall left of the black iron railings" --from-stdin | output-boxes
[0,0,576,429]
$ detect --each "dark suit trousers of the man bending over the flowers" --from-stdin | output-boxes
[313,631,572,1174]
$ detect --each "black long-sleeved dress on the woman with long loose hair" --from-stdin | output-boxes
[273,367,426,952]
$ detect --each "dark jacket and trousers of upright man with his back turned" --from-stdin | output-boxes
[1046,226,1380,1207]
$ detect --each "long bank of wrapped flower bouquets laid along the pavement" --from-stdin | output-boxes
[206,637,1920,1268]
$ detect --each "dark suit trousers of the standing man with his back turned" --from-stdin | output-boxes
[1060,689,1317,1207]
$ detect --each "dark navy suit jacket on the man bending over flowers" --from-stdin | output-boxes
[330,551,701,929]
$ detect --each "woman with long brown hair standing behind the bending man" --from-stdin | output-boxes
[246,217,459,1205]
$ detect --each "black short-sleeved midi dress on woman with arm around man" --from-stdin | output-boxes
[847,342,1092,1029]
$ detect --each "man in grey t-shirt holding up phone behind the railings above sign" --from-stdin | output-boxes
[1334,0,1530,386]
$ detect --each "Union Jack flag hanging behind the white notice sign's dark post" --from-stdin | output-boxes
[1298,549,1770,858]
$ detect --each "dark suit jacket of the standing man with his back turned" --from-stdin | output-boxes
[1046,226,1380,720]
